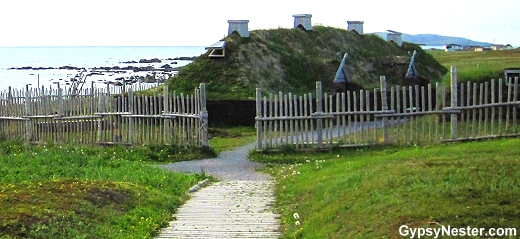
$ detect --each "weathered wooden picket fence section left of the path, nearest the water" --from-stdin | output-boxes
[0,84,208,146]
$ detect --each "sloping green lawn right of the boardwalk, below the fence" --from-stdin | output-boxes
[251,139,520,238]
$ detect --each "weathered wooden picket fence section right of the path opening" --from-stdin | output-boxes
[256,67,520,151]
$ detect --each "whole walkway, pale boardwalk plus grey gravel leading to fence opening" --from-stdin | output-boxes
[157,144,281,238]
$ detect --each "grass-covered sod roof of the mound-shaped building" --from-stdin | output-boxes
[168,26,447,100]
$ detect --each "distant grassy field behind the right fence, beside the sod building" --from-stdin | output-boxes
[428,49,520,86]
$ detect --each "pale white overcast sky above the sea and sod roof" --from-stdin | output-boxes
[0,0,520,46]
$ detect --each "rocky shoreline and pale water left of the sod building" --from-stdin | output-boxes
[0,46,205,92]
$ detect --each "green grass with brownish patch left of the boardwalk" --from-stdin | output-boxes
[0,141,206,238]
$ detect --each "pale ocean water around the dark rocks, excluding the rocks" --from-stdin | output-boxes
[0,46,205,91]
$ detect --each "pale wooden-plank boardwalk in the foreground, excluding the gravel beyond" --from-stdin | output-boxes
[157,180,281,239]
